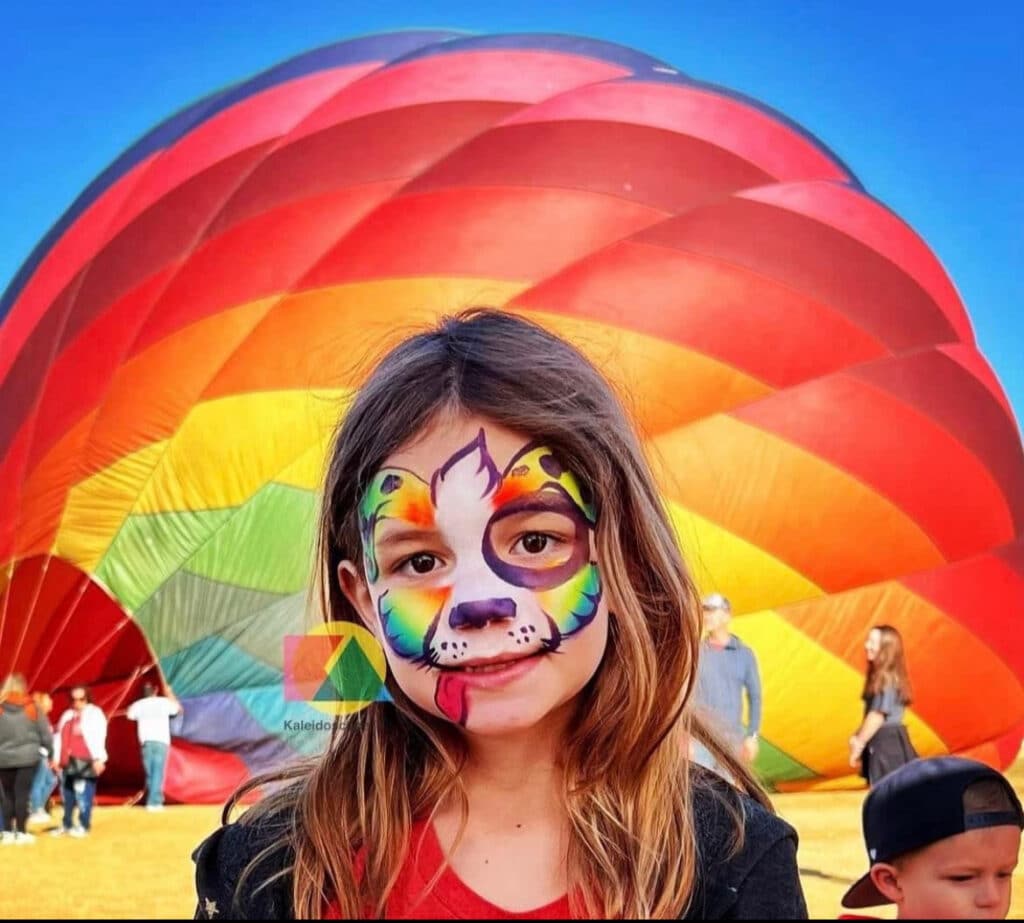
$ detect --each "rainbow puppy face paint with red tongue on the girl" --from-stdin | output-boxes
[359,429,602,724]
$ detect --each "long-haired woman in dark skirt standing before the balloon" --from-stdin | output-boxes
[850,625,918,786]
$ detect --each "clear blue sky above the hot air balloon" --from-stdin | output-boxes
[0,0,1024,421]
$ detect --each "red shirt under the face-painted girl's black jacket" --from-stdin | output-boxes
[324,822,570,920]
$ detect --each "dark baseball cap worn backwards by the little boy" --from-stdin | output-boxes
[843,756,1024,909]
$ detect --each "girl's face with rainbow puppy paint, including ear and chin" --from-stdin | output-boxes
[338,417,608,735]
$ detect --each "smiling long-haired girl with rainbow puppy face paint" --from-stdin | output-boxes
[194,310,807,919]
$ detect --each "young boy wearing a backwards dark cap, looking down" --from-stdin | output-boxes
[841,756,1024,920]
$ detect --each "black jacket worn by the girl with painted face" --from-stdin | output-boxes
[193,774,807,920]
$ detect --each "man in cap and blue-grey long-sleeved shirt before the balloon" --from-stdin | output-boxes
[693,593,761,769]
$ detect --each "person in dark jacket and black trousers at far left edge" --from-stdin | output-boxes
[0,673,53,845]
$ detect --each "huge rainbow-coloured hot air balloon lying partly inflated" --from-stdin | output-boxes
[0,32,1024,801]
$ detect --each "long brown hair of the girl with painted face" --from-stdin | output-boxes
[224,309,768,918]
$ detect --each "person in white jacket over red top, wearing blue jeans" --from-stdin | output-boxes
[51,685,106,837]
